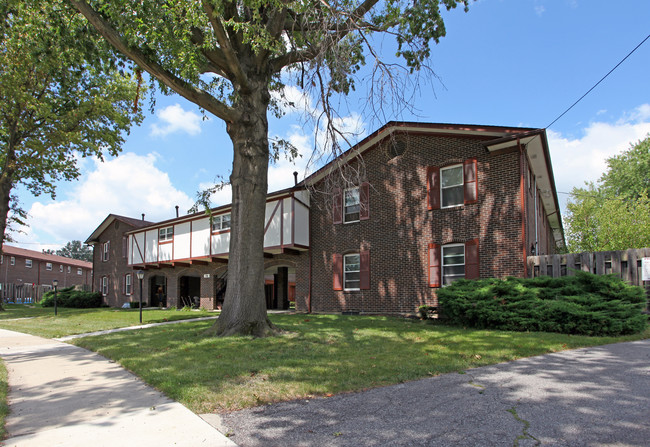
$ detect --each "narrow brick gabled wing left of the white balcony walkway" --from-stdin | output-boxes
[86,214,151,307]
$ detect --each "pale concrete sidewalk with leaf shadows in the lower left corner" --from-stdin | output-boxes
[0,330,236,447]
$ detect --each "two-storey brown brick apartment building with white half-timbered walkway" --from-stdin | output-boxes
[87,122,564,314]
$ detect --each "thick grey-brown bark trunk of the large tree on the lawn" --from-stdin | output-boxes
[208,82,277,337]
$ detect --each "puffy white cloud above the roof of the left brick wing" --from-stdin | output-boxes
[26,152,193,243]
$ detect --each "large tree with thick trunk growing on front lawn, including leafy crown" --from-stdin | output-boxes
[68,0,469,336]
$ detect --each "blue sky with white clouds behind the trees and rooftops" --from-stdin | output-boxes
[14,0,650,250]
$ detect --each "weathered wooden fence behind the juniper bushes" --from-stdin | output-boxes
[528,248,650,308]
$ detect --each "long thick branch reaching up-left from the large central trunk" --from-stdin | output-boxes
[69,0,239,122]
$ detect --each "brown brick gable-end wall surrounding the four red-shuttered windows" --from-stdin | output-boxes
[296,135,524,313]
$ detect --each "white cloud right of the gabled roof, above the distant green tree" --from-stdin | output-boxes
[548,104,650,208]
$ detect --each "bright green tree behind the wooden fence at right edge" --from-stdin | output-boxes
[564,136,650,253]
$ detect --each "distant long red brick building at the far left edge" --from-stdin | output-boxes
[0,244,93,302]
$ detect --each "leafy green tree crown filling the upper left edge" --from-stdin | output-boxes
[0,0,140,251]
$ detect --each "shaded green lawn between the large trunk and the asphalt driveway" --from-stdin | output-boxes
[63,315,650,413]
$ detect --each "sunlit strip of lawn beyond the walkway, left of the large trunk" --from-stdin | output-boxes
[0,304,216,338]
